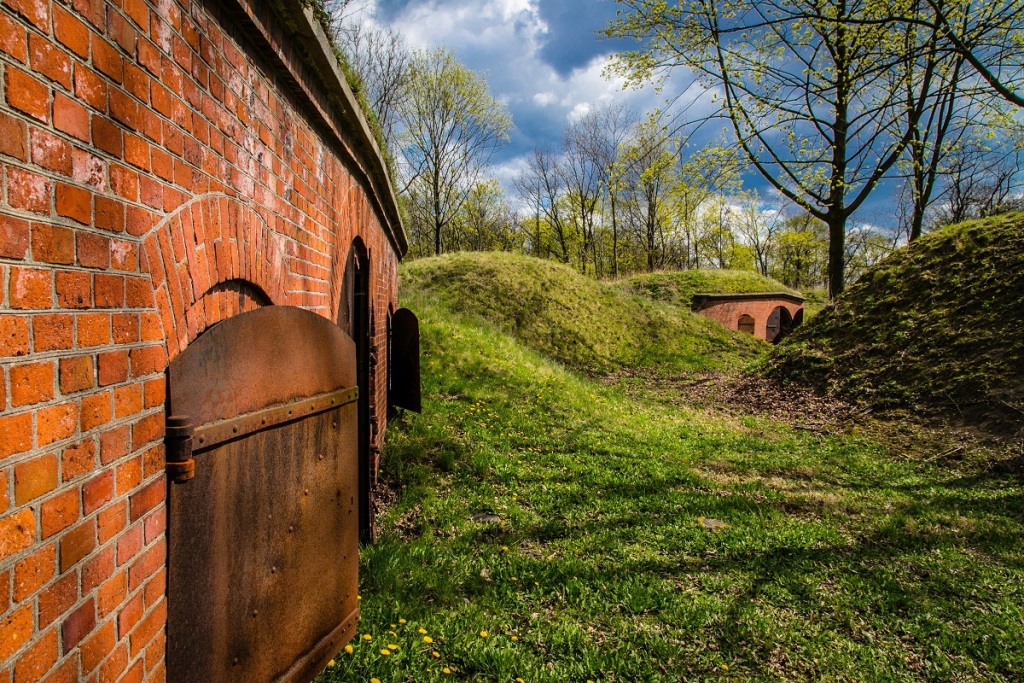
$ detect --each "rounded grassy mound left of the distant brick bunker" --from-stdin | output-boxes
[402,253,767,373]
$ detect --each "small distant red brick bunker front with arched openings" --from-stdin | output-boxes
[692,292,804,343]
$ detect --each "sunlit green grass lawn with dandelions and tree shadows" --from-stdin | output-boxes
[317,292,1024,683]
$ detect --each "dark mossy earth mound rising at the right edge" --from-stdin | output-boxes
[771,214,1024,430]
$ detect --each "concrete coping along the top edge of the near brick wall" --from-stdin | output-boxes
[233,0,409,258]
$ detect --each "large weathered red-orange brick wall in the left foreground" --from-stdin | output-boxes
[0,0,400,683]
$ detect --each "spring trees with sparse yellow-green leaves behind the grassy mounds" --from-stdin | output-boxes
[332,0,1024,293]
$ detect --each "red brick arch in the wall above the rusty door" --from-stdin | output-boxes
[142,193,295,362]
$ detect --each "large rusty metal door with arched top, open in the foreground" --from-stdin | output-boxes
[167,306,358,683]
